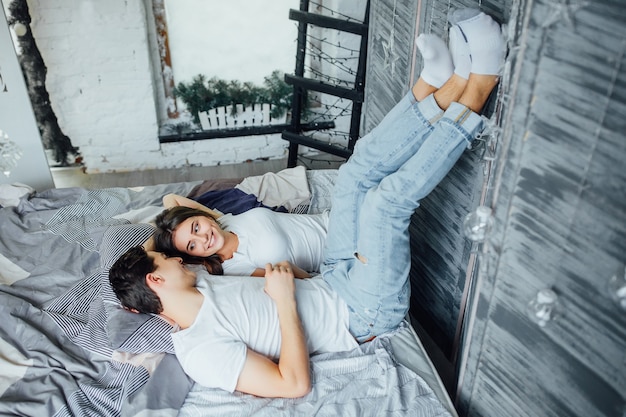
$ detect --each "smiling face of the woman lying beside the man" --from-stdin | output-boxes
[172,216,224,256]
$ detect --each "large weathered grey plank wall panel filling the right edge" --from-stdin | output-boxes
[459,0,626,417]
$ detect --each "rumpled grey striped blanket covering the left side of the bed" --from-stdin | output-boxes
[0,183,196,416]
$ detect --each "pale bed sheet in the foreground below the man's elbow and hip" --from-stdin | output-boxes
[179,323,458,417]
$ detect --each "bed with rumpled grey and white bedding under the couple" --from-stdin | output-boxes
[0,168,456,416]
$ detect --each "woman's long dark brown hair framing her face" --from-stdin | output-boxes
[154,206,224,275]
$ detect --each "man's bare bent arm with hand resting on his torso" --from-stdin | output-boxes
[235,262,311,398]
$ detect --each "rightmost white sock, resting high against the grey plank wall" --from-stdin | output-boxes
[450,12,505,75]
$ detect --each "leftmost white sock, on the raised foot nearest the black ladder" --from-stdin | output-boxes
[415,33,454,88]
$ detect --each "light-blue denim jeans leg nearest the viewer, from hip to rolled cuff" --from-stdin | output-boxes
[330,98,482,341]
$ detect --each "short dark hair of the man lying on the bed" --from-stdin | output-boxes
[109,246,163,314]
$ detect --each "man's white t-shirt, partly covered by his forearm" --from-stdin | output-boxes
[172,271,357,392]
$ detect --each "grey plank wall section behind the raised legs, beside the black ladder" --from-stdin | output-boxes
[362,0,509,364]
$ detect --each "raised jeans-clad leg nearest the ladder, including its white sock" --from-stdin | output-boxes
[325,35,456,259]
